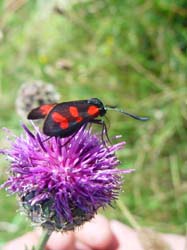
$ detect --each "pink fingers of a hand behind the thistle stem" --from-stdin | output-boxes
[2,215,185,250]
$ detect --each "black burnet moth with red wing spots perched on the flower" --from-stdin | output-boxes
[27,98,148,138]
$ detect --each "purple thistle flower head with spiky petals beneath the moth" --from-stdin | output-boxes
[0,125,132,231]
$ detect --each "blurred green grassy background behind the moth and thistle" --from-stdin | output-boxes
[0,0,187,244]
